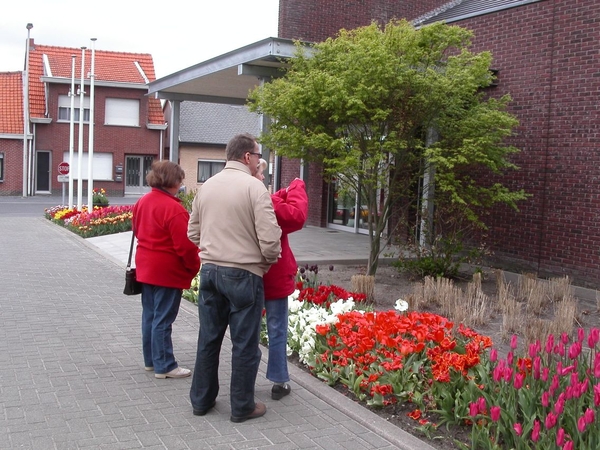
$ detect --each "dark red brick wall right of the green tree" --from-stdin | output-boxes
[459,0,600,286]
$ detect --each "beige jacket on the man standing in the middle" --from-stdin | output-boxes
[188,161,281,277]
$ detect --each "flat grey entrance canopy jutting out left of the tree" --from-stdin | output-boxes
[148,38,309,105]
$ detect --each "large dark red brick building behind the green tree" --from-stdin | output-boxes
[279,0,600,286]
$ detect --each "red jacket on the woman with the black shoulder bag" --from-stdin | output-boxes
[133,188,200,289]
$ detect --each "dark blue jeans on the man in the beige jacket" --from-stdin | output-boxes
[190,264,265,417]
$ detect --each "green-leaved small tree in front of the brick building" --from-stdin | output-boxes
[249,21,526,275]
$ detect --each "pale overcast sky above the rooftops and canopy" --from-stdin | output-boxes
[0,0,279,78]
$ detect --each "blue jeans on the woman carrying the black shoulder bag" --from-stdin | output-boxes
[142,283,182,373]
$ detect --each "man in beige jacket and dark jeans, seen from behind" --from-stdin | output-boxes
[188,134,281,422]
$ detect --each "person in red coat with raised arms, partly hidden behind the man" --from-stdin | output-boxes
[256,159,308,400]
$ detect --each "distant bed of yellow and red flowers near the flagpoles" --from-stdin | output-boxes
[45,205,133,238]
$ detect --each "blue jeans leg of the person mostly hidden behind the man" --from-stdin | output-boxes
[265,297,290,383]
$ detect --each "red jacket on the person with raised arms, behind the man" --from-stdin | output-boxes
[263,178,308,300]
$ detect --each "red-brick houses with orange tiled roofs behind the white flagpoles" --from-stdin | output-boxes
[0,39,166,199]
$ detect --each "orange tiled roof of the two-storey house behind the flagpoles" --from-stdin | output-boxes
[26,39,164,124]
